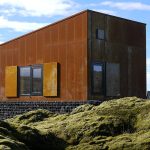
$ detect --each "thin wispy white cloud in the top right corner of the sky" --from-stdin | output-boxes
[101,1,150,10]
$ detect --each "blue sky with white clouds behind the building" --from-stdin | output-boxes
[0,0,150,90]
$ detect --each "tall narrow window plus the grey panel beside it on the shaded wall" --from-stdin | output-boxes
[91,62,120,97]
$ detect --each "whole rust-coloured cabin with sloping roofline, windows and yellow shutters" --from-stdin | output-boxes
[0,10,146,102]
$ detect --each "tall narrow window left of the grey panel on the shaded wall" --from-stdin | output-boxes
[92,63,104,95]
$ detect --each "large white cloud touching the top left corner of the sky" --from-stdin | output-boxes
[0,0,77,17]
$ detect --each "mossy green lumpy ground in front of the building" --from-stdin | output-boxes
[0,97,150,150]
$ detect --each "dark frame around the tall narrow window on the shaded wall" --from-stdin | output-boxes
[91,62,106,96]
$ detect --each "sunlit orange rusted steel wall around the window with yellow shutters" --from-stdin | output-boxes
[0,11,87,101]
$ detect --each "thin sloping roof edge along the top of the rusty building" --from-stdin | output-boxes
[0,9,146,46]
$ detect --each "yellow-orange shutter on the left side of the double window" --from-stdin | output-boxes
[5,66,17,97]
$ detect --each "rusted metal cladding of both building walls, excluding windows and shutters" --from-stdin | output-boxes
[0,10,146,101]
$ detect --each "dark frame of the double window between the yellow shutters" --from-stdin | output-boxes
[18,65,43,96]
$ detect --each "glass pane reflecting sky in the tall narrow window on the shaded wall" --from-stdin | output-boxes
[93,64,103,94]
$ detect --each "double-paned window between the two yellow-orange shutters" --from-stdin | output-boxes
[19,66,42,95]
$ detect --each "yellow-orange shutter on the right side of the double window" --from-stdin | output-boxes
[43,62,58,96]
